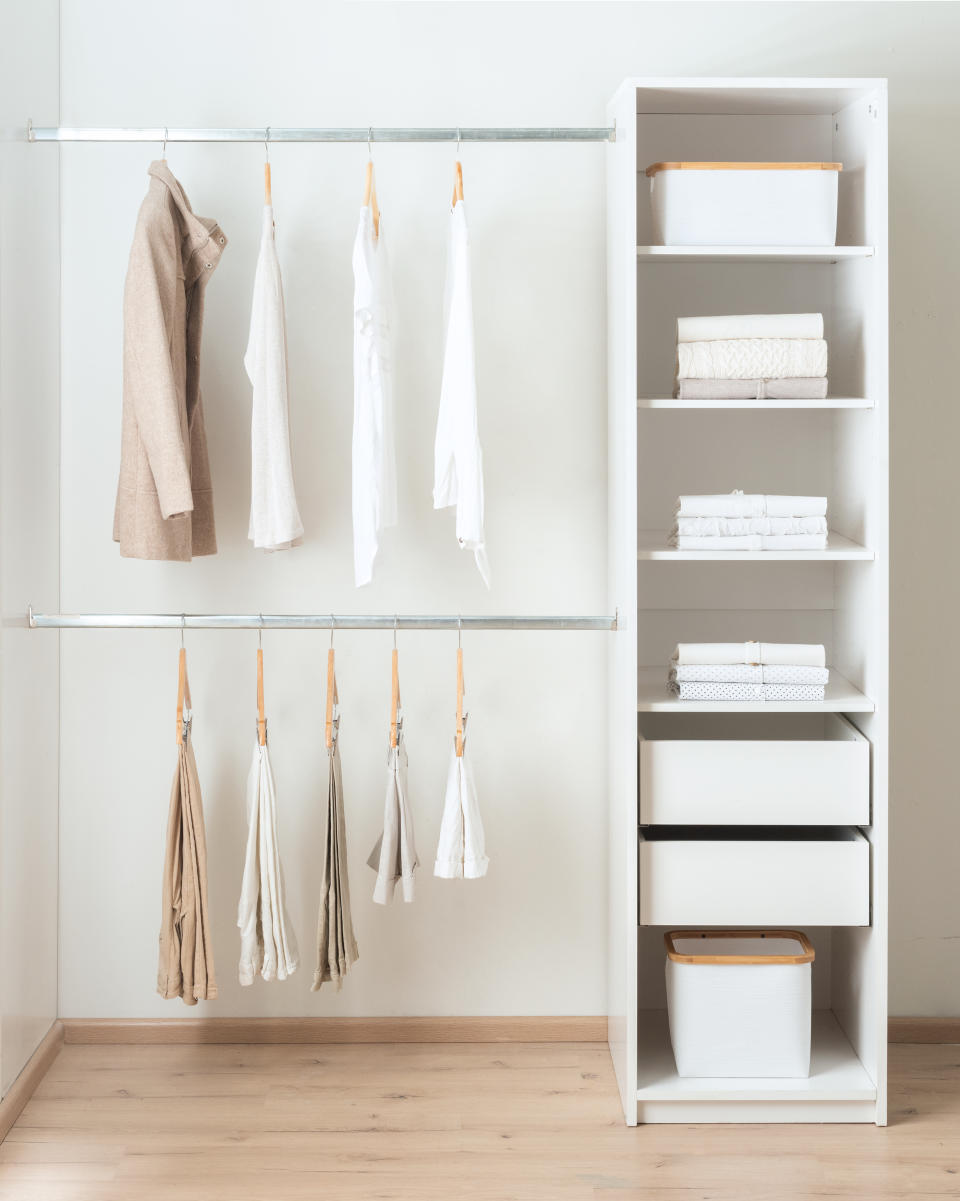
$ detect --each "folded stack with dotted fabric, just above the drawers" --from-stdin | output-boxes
[670,643,830,700]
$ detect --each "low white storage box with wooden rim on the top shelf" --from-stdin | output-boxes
[646,162,842,246]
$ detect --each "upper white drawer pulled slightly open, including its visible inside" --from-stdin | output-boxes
[638,713,870,825]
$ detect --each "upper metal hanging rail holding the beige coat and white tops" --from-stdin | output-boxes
[26,121,616,143]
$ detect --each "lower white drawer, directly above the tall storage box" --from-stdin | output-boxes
[640,826,870,927]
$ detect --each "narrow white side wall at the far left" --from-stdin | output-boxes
[0,0,60,1095]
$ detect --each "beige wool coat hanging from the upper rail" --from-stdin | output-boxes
[113,162,227,561]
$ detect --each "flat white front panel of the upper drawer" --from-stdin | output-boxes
[639,718,870,825]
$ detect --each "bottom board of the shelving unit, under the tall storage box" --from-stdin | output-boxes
[637,1009,877,1101]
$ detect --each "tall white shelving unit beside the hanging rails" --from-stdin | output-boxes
[607,79,889,1125]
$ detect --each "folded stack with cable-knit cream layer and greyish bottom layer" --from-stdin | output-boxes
[676,312,827,400]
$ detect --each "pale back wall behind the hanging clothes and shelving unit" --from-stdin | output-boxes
[54,0,960,1016]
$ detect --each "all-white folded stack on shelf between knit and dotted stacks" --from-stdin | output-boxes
[670,492,827,550]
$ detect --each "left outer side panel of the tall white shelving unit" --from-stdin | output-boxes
[607,89,638,1125]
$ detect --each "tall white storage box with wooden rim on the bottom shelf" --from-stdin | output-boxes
[663,930,813,1077]
